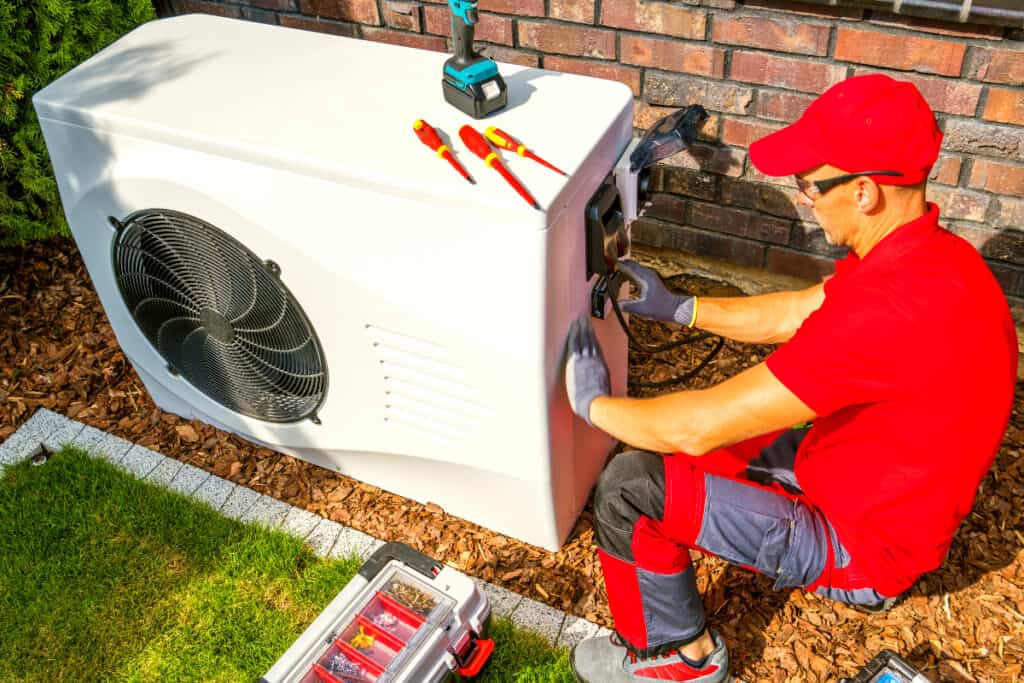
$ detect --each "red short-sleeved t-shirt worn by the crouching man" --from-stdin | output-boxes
[767,204,1017,596]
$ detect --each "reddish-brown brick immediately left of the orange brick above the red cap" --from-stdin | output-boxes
[712,14,831,56]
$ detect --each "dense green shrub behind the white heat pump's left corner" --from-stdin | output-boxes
[0,0,156,246]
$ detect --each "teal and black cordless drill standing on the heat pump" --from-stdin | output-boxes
[442,0,508,119]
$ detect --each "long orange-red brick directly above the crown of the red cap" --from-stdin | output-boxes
[835,27,967,76]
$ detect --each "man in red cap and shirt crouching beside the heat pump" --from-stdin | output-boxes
[566,76,1017,683]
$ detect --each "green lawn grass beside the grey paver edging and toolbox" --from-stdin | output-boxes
[0,450,572,683]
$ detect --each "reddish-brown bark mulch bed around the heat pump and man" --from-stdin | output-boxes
[0,240,1024,682]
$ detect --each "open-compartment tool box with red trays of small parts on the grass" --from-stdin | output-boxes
[260,543,495,683]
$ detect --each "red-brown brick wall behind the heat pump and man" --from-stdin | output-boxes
[168,0,1024,304]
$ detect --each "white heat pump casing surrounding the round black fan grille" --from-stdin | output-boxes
[34,15,633,549]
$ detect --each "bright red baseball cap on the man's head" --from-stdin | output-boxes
[750,74,942,185]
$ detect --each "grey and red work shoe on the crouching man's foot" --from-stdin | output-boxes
[569,629,729,683]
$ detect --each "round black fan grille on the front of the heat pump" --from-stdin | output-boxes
[113,209,327,422]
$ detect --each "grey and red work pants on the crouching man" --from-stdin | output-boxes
[594,429,886,656]
